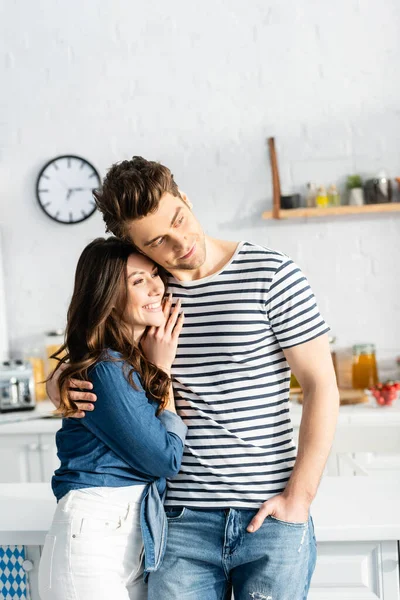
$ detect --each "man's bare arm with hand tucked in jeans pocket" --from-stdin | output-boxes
[248,334,339,531]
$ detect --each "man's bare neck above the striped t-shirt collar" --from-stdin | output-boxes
[169,236,238,281]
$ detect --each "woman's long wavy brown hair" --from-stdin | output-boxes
[49,237,171,417]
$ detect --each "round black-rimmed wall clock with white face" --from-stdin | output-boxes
[36,155,100,225]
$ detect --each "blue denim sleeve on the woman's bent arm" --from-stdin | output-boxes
[82,361,187,478]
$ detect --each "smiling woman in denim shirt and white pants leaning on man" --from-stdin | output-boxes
[39,237,187,600]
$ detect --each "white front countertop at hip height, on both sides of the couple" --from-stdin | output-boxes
[0,475,400,545]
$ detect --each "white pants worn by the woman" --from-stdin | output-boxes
[39,486,147,600]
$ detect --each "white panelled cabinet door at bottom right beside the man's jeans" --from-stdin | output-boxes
[308,542,400,600]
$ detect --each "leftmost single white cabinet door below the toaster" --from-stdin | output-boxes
[0,434,42,483]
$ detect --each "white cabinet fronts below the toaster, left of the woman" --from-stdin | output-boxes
[0,430,59,483]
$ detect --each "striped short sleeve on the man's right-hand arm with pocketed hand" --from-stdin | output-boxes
[266,259,329,348]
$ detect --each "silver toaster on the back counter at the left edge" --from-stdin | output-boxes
[0,360,36,413]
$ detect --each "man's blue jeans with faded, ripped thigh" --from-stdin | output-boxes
[148,507,316,600]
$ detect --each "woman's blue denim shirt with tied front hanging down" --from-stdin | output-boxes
[52,350,187,574]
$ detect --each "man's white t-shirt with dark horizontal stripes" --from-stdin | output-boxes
[162,242,328,509]
